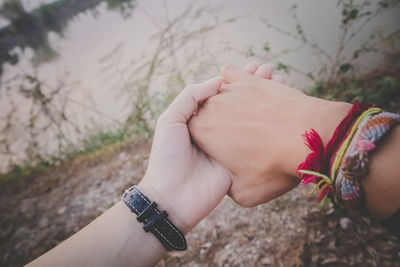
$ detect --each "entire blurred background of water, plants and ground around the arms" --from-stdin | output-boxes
[0,0,400,266]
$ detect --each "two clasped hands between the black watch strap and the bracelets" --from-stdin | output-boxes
[139,63,342,232]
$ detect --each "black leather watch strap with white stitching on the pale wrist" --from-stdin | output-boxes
[122,186,187,250]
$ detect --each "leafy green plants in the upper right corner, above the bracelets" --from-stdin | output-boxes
[262,0,400,112]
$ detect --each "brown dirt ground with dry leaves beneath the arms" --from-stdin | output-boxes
[0,140,400,266]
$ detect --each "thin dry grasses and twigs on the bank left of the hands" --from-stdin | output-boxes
[0,1,233,191]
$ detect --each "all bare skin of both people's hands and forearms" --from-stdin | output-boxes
[29,63,400,266]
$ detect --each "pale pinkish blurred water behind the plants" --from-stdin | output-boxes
[0,0,400,170]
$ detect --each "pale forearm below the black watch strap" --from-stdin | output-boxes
[29,201,166,266]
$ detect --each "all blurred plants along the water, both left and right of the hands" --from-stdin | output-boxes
[0,0,400,189]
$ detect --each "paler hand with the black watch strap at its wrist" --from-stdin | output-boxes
[138,78,231,233]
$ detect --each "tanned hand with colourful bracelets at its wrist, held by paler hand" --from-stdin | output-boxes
[189,66,350,206]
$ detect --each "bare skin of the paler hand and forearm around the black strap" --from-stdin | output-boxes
[29,78,231,266]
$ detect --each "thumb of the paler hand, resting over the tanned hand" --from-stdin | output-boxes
[160,77,222,123]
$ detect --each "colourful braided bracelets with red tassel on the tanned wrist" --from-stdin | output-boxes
[298,103,400,213]
